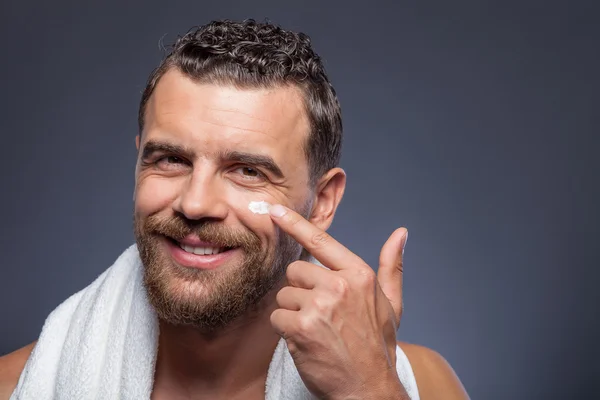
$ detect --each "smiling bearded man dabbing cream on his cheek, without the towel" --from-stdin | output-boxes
[0,21,467,400]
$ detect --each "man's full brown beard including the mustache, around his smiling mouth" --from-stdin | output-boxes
[134,214,302,334]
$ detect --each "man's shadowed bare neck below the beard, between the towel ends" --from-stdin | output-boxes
[154,286,280,398]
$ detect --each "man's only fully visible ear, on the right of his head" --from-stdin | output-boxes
[309,168,346,231]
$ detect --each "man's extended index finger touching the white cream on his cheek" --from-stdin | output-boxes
[269,204,366,271]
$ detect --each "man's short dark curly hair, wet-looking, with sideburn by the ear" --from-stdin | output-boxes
[138,20,342,185]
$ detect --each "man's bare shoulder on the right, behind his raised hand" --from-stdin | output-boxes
[398,342,469,400]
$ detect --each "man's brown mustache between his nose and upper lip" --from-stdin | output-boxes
[143,215,261,249]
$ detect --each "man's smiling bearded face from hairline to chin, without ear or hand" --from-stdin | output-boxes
[134,70,311,332]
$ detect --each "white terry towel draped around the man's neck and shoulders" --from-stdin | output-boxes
[10,245,419,400]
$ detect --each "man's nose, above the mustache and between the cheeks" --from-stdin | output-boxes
[173,171,228,220]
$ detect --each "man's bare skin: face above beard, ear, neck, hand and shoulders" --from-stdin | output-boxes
[0,70,468,400]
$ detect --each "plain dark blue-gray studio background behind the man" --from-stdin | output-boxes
[0,0,600,399]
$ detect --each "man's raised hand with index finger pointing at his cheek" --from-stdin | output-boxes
[271,206,408,399]
